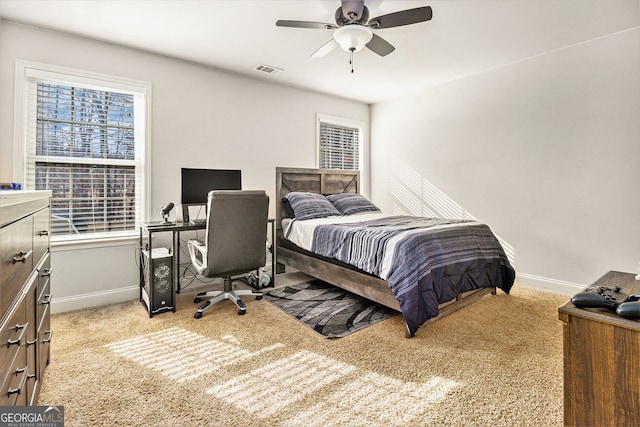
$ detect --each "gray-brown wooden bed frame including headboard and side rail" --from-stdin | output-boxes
[276,167,496,337]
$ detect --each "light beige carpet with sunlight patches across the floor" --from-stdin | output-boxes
[39,276,567,426]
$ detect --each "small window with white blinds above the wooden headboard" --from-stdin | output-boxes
[318,116,363,170]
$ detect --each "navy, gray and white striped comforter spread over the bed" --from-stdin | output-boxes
[285,213,515,334]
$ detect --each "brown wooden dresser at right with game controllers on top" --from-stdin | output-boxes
[558,271,640,426]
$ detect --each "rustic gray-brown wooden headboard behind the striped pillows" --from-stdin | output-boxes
[276,167,360,229]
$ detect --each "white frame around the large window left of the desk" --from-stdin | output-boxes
[13,60,152,244]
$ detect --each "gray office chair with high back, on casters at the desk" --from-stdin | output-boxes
[187,190,269,319]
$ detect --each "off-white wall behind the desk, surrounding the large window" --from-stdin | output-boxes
[0,22,369,311]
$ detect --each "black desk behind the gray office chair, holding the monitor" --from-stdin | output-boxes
[139,218,276,317]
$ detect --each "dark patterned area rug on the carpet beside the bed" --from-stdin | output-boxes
[264,280,398,338]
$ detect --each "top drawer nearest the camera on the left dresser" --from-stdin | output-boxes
[0,217,34,315]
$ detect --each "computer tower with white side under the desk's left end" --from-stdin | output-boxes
[142,248,176,317]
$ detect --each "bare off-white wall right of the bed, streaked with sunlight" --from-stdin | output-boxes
[371,27,640,293]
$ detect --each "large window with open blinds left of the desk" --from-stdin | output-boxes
[16,61,149,238]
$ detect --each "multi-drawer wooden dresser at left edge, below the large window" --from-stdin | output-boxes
[0,190,52,406]
